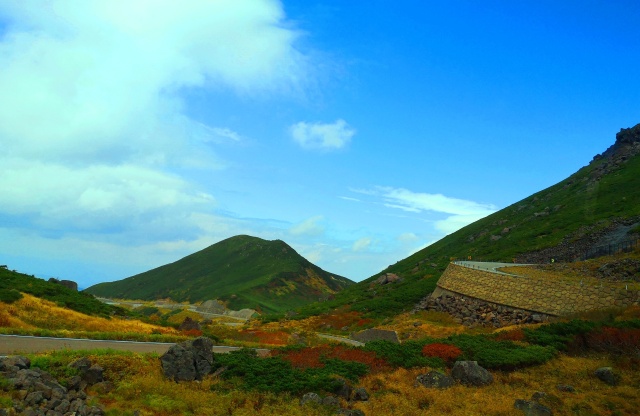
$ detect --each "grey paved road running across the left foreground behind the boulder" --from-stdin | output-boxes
[0,335,268,354]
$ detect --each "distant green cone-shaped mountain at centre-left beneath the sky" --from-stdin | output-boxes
[85,235,353,312]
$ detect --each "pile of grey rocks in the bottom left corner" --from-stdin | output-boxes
[0,356,104,416]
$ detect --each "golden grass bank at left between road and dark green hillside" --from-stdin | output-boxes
[0,293,177,334]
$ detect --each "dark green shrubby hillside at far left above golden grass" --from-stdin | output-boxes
[0,268,125,316]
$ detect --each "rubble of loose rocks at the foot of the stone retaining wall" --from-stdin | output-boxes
[413,294,549,328]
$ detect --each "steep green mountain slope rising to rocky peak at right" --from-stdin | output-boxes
[300,124,640,317]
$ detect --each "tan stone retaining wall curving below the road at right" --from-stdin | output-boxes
[433,264,640,316]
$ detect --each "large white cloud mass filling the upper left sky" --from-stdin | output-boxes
[0,0,310,242]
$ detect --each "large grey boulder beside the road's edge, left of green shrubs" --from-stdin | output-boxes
[160,337,213,382]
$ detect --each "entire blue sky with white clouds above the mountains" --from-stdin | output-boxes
[0,0,640,287]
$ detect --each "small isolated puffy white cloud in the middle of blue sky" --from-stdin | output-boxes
[289,119,356,150]
